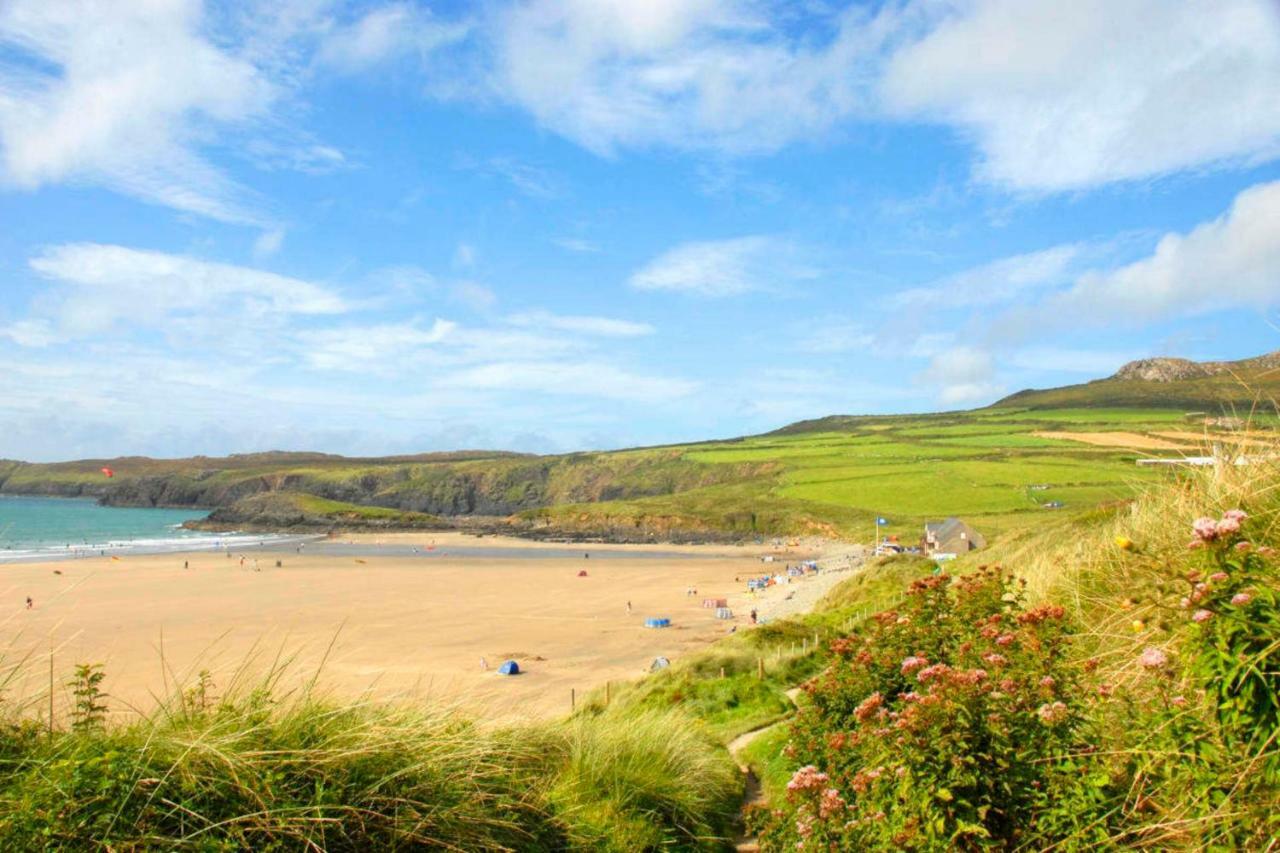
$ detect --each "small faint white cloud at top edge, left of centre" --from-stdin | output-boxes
[316,3,467,73]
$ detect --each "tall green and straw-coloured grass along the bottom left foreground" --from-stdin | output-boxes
[0,660,741,850]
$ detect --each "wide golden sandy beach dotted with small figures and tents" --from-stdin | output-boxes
[0,534,837,719]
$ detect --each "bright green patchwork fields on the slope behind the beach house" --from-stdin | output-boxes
[529,409,1244,539]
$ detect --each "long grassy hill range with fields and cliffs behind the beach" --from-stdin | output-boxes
[0,353,1280,540]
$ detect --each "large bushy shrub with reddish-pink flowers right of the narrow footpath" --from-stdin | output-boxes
[759,560,1119,849]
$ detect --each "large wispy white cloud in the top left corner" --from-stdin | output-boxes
[0,0,276,223]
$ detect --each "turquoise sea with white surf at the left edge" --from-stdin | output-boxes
[0,496,299,562]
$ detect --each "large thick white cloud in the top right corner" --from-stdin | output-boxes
[883,0,1280,191]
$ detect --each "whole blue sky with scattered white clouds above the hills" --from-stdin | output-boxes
[0,0,1280,461]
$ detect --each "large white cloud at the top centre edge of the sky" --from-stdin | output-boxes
[492,0,901,154]
